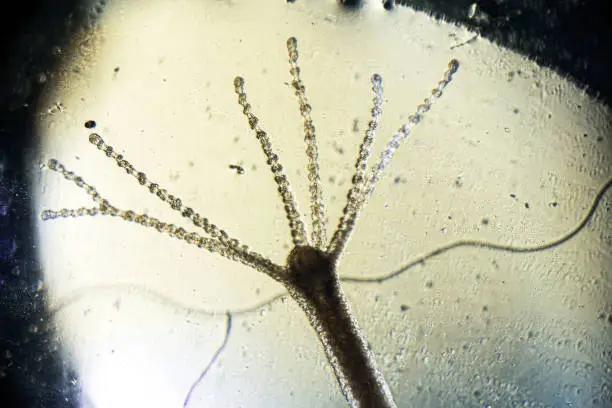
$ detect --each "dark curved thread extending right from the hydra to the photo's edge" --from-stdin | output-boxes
[341,175,612,283]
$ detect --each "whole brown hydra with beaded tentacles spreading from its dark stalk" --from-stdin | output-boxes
[41,37,459,408]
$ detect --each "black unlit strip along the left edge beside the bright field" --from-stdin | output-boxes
[0,0,104,408]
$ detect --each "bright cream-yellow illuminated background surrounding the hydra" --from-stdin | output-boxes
[35,0,612,408]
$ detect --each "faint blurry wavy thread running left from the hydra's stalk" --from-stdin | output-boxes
[49,283,287,318]
